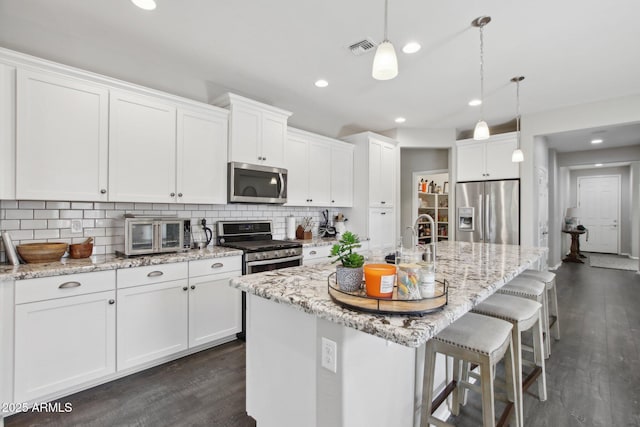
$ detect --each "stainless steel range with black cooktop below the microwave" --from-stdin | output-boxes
[216,221,302,340]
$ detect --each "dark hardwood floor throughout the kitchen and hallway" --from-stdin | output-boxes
[5,262,640,427]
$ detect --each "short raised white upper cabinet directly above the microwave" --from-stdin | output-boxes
[214,93,291,167]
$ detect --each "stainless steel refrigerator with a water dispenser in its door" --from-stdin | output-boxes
[455,179,520,245]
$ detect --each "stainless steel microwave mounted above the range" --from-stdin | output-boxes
[228,162,287,204]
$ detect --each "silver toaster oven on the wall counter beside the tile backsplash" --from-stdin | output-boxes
[116,214,184,257]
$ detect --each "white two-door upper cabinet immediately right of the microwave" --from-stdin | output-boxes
[285,128,331,206]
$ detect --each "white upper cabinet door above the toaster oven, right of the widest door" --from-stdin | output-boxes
[109,91,176,203]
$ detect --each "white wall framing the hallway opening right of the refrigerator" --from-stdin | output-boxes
[520,95,640,246]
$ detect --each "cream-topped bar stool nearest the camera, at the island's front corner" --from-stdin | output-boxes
[425,313,522,427]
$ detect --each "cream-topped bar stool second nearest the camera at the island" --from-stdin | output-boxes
[470,294,547,423]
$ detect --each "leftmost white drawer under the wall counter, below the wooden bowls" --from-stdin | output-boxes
[15,270,116,304]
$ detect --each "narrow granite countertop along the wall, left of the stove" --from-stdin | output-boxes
[0,246,242,281]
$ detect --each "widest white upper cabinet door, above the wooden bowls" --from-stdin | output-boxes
[16,70,109,201]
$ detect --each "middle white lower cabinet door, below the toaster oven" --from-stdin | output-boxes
[117,279,189,371]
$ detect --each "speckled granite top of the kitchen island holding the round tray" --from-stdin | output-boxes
[231,242,547,347]
